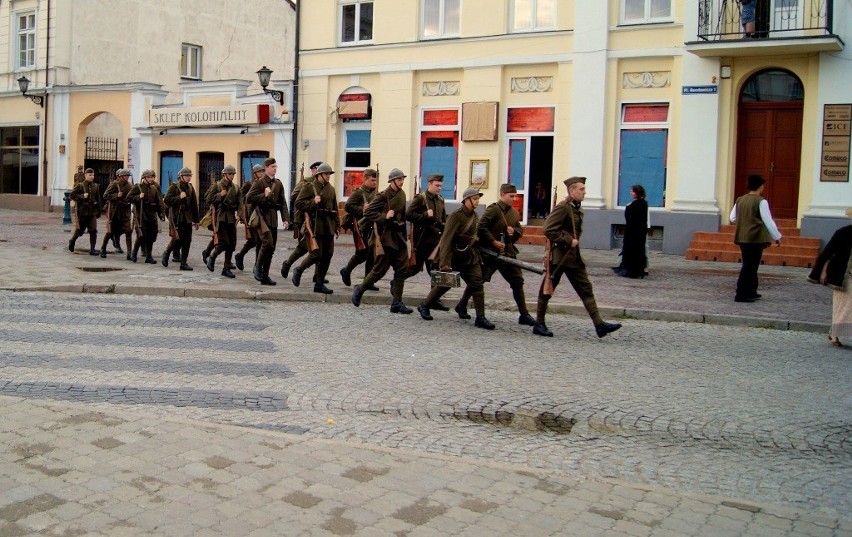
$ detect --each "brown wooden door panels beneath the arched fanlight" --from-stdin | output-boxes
[734,102,802,218]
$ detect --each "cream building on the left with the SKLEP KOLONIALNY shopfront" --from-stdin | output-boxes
[0,0,296,209]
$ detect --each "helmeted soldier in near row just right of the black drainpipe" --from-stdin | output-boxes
[293,163,340,295]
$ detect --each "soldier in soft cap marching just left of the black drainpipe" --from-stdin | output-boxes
[246,158,289,285]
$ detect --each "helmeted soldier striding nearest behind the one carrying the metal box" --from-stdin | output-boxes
[352,168,414,314]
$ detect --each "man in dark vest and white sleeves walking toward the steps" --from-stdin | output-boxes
[731,175,781,302]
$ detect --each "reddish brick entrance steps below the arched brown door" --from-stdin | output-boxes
[686,218,820,268]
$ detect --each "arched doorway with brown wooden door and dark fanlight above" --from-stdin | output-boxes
[734,69,804,218]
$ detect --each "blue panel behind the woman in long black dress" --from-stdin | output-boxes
[618,129,669,207]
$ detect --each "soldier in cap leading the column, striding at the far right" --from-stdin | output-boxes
[533,177,621,337]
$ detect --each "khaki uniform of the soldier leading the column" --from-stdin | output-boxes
[536,201,604,326]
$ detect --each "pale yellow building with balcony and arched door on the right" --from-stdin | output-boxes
[297,0,852,253]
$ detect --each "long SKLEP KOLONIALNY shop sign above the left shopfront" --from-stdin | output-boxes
[148,104,269,129]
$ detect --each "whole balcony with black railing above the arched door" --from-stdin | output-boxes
[685,0,844,57]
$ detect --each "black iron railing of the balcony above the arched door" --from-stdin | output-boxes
[698,0,833,41]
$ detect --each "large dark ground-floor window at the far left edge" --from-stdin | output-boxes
[0,127,39,194]
